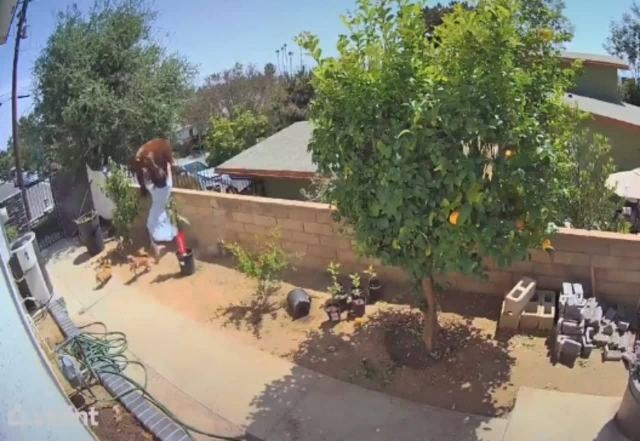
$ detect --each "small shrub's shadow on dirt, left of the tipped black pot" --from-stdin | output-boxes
[215,291,282,339]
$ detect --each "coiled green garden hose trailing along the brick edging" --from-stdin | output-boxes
[56,322,243,441]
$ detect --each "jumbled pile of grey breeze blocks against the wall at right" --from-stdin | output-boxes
[555,283,635,365]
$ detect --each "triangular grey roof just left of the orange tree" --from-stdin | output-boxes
[216,121,316,178]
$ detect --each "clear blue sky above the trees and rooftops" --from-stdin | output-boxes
[0,0,632,150]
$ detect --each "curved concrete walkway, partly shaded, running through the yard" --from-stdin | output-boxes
[43,241,632,441]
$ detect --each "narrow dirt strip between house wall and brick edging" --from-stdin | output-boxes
[37,316,155,441]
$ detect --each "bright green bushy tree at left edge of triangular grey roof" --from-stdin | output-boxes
[204,106,269,167]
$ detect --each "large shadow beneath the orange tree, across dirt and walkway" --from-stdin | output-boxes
[242,308,515,441]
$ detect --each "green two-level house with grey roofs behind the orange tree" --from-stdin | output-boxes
[562,52,640,170]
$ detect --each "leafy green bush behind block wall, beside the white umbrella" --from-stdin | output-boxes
[558,119,624,232]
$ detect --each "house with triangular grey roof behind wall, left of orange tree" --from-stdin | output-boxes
[216,121,316,200]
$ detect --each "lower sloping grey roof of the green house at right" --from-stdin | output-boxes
[564,94,640,131]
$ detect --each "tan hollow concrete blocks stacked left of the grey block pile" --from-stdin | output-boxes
[498,277,556,331]
